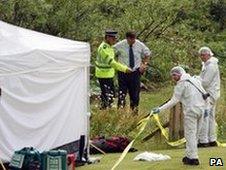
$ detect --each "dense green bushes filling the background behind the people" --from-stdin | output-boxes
[0,0,226,82]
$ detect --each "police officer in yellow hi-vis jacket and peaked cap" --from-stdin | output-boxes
[95,30,131,109]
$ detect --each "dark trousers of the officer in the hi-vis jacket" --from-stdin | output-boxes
[98,78,115,109]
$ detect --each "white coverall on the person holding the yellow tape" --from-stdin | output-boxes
[159,73,206,159]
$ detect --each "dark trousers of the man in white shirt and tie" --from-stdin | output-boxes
[118,70,141,110]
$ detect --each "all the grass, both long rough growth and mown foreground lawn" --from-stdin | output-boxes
[87,81,226,170]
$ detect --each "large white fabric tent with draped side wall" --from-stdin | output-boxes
[0,21,90,161]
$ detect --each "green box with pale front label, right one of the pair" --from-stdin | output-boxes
[41,150,67,170]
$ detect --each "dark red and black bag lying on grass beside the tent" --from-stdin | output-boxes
[90,136,137,154]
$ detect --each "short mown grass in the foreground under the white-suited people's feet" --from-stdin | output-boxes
[76,147,226,170]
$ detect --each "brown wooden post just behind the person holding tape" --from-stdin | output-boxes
[169,103,184,141]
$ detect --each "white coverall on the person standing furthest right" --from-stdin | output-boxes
[199,57,220,143]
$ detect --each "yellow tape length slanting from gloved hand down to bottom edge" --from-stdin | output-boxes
[111,112,152,170]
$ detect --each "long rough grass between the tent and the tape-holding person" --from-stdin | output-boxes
[91,86,172,150]
